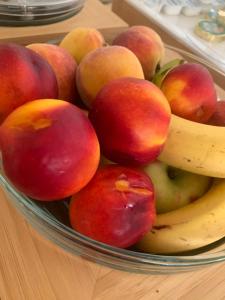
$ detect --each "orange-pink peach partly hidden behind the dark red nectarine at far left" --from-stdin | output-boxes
[27,43,78,103]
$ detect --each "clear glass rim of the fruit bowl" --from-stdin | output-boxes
[0,44,225,271]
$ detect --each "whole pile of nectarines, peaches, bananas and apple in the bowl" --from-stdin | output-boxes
[0,26,225,253]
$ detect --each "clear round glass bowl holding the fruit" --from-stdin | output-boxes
[0,46,225,274]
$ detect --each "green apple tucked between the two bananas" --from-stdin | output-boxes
[144,161,211,214]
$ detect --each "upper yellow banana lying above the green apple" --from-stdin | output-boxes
[158,115,225,178]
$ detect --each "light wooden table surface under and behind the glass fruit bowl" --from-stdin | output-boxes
[0,0,225,300]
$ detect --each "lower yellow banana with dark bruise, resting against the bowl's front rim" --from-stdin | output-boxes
[137,179,225,254]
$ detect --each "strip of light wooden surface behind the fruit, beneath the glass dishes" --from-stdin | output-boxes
[0,0,127,44]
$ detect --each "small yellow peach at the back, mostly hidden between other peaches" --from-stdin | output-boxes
[60,27,105,64]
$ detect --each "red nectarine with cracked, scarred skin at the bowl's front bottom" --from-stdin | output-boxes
[69,165,155,248]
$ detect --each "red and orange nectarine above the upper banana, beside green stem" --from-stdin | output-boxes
[161,63,217,123]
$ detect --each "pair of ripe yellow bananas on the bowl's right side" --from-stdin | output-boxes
[137,115,225,254]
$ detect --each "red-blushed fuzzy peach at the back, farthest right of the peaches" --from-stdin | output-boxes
[113,26,165,79]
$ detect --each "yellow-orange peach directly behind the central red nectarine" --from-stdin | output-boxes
[77,46,144,107]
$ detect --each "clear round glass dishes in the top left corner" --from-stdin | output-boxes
[0,0,85,26]
